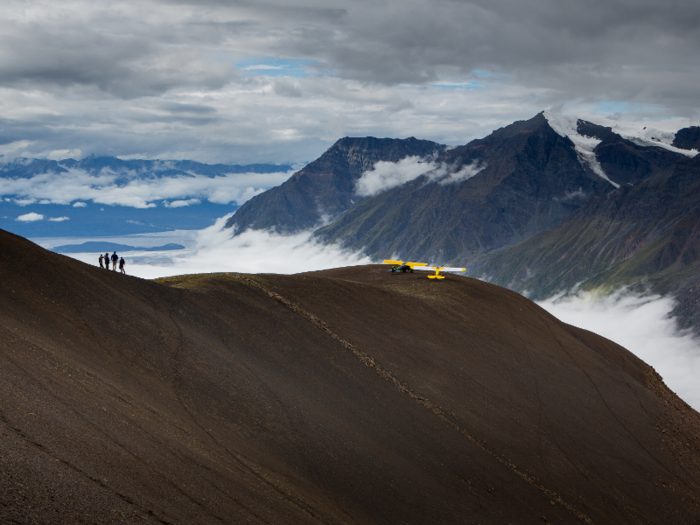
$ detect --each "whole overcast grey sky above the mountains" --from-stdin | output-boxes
[0,0,700,163]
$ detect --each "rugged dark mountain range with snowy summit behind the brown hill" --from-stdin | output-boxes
[227,112,700,328]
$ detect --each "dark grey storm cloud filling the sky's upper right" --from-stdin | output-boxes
[274,0,700,106]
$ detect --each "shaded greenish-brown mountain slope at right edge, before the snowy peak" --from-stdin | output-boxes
[472,152,700,327]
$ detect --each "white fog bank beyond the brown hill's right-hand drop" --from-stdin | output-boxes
[538,291,700,410]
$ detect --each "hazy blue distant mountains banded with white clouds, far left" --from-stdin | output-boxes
[0,156,292,238]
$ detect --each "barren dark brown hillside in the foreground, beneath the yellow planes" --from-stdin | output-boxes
[0,229,700,524]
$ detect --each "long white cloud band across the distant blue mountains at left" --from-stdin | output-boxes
[0,169,292,208]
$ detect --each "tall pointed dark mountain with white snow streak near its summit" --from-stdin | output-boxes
[316,114,685,265]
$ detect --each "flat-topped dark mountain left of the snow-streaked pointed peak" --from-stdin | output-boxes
[226,137,445,233]
